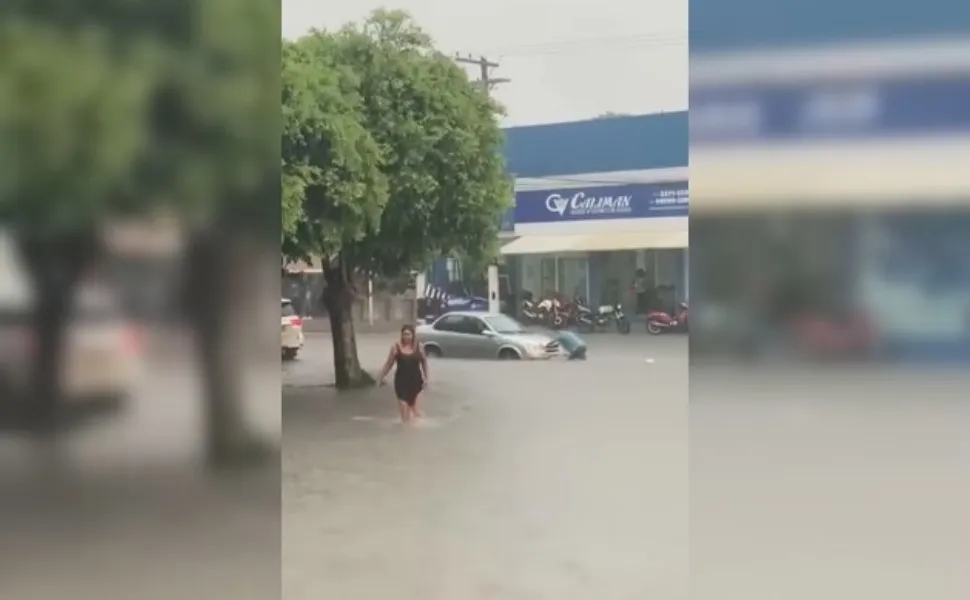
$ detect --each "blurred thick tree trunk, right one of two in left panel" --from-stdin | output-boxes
[186,232,272,468]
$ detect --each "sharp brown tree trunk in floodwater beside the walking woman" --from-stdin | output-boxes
[324,264,374,390]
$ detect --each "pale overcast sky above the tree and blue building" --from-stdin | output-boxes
[282,0,688,126]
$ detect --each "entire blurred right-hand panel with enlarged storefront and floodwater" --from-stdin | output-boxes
[690,0,970,600]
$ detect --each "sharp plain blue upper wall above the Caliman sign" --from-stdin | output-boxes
[505,111,688,178]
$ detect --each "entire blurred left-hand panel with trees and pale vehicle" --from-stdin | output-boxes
[0,0,280,600]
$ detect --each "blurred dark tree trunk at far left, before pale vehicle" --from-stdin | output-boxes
[20,233,98,433]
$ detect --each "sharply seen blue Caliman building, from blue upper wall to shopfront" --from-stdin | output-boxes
[493,112,689,310]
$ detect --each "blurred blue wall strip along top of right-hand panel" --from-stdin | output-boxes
[690,0,970,53]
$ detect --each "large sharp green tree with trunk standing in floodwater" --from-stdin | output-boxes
[284,11,511,387]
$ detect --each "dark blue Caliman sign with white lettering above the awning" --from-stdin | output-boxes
[515,181,689,224]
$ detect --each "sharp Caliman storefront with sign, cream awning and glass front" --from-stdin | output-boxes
[502,179,689,311]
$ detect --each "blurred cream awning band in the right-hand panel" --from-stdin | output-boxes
[690,136,970,216]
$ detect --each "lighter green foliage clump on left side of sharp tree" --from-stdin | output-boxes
[282,33,387,258]
